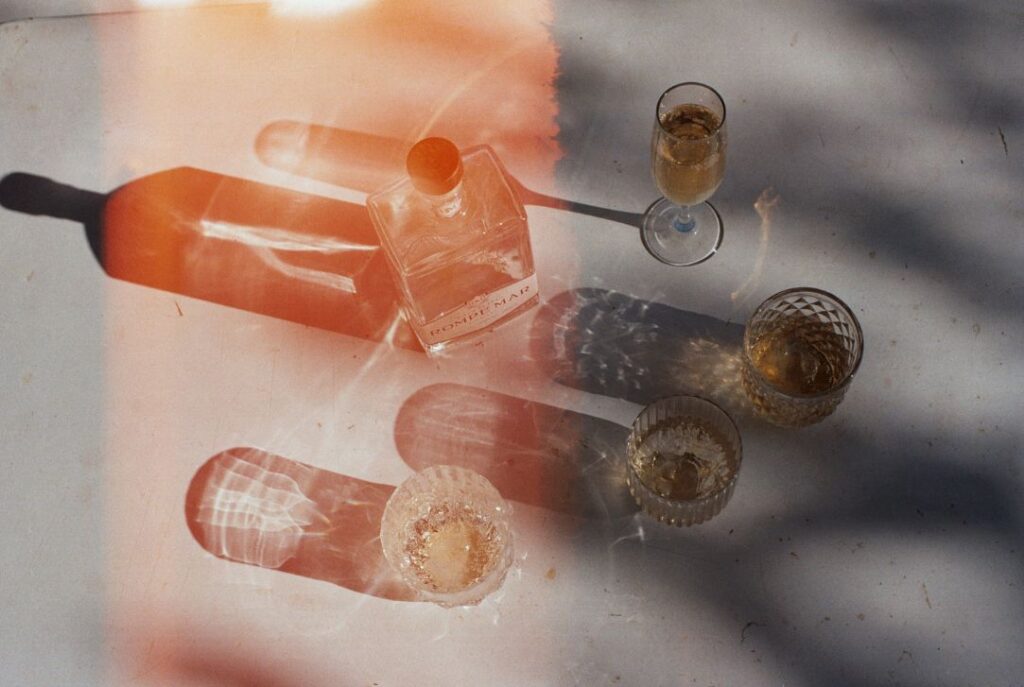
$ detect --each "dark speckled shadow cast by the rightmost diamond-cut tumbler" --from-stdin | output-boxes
[530,288,754,418]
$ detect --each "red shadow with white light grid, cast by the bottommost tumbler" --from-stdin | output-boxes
[184,447,415,601]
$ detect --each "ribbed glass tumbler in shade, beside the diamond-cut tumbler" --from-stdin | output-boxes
[627,396,742,526]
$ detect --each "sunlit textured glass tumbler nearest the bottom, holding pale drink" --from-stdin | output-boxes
[381,466,512,607]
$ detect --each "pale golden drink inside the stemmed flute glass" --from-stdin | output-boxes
[651,103,725,206]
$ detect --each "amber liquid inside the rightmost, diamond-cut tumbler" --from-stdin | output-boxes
[751,317,847,395]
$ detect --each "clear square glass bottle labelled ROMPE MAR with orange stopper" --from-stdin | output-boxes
[368,137,540,353]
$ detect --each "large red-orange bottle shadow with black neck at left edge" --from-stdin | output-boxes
[0,167,421,350]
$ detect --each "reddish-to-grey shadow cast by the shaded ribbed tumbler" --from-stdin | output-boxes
[394,384,637,519]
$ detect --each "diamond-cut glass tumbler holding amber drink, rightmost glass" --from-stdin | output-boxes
[742,289,863,427]
